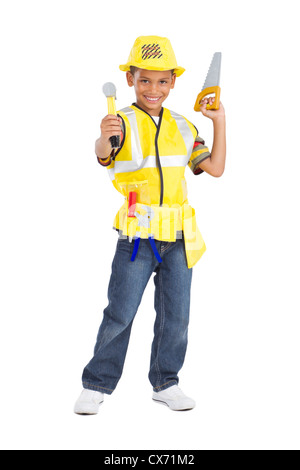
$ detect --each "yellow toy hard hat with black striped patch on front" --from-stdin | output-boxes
[120,36,185,77]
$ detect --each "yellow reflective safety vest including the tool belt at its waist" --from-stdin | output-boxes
[107,105,206,268]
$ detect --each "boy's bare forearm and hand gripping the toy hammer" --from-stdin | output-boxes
[95,114,122,163]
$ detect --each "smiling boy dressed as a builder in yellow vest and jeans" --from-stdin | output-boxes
[75,36,226,414]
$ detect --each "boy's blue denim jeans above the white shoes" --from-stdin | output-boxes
[82,238,192,395]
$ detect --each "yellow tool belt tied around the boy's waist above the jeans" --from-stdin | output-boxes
[114,200,206,268]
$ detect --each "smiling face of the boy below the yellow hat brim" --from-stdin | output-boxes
[126,69,176,116]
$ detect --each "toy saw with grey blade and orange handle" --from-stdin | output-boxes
[194,52,222,111]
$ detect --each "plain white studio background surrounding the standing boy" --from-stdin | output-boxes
[0,0,300,450]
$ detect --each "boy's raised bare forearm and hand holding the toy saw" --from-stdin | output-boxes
[199,98,226,177]
